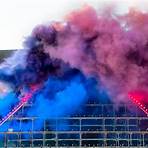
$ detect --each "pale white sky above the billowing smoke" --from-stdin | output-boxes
[0,0,148,50]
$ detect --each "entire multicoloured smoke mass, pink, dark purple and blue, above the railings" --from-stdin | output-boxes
[0,6,148,130]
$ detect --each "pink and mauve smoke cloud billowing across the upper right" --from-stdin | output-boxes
[33,6,148,104]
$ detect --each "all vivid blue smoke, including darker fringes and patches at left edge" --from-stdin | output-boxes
[0,66,107,132]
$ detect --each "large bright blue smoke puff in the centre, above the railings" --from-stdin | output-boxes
[27,74,87,130]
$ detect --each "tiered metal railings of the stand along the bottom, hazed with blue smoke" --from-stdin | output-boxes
[0,51,148,148]
